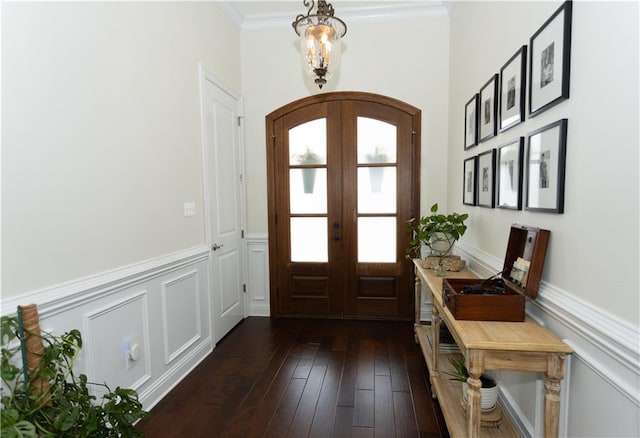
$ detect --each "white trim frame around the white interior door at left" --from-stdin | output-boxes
[198,62,248,342]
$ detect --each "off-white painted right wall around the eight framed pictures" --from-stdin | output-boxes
[448,1,640,326]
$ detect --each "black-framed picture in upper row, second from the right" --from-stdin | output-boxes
[500,46,527,131]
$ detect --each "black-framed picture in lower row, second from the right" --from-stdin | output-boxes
[496,137,524,210]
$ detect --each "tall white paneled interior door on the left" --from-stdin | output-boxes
[201,68,245,342]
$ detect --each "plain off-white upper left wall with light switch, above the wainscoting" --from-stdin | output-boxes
[2,2,240,297]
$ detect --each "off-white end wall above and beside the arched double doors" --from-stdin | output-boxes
[242,5,449,234]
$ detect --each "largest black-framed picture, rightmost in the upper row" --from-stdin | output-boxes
[529,1,572,116]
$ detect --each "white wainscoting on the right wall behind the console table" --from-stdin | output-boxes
[456,242,640,437]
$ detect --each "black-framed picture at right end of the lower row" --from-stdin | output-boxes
[526,119,567,213]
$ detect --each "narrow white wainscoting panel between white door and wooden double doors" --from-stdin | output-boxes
[247,235,271,316]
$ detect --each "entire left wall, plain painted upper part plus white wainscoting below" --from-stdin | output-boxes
[0,2,240,409]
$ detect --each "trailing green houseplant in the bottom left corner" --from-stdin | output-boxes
[0,316,146,438]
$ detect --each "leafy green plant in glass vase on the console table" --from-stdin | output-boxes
[406,203,469,271]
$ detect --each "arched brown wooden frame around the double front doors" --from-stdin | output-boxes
[265,91,422,316]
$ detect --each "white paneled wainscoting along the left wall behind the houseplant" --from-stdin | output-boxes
[2,245,213,409]
